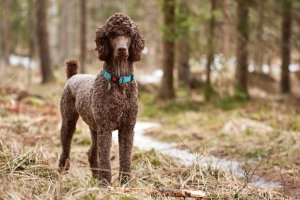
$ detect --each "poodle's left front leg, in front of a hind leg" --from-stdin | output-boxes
[97,128,112,185]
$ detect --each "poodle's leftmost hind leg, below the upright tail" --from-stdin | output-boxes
[59,88,79,172]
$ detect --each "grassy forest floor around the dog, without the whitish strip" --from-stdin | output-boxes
[0,68,300,199]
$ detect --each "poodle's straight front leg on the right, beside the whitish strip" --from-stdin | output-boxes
[119,125,134,184]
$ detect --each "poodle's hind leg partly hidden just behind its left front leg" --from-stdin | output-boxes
[88,129,99,178]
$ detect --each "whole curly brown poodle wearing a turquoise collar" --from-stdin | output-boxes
[59,13,144,184]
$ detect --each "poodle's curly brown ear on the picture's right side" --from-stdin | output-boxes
[129,25,145,62]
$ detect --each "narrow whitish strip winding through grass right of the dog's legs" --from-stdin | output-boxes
[113,122,282,189]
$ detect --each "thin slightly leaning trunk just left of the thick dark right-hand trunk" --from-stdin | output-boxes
[205,0,217,101]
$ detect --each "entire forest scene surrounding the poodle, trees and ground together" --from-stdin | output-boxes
[0,0,300,200]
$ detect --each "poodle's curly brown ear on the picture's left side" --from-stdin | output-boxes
[95,26,112,61]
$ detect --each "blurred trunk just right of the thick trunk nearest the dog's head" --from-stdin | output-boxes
[176,0,191,86]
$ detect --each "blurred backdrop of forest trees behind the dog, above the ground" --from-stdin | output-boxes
[0,0,300,99]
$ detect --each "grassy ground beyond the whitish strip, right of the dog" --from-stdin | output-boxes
[141,94,300,197]
